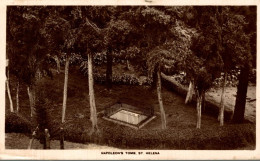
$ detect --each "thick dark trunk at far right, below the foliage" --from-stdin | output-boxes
[233,66,249,123]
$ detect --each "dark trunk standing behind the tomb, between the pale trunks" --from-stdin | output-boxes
[106,49,113,89]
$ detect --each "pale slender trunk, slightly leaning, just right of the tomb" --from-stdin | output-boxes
[157,69,166,129]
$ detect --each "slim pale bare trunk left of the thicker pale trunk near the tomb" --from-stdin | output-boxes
[61,56,69,123]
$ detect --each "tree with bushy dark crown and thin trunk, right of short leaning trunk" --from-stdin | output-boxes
[185,7,226,128]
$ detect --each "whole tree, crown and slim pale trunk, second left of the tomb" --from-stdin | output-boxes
[45,7,80,123]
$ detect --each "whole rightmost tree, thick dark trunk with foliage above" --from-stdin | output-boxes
[233,6,256,123]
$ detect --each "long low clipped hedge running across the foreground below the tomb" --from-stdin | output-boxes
[6,113,256,150]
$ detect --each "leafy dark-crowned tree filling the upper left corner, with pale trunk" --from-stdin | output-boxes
[7,6,51,116]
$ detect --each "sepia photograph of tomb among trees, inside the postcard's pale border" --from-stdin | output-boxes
[2,1,257,159]
